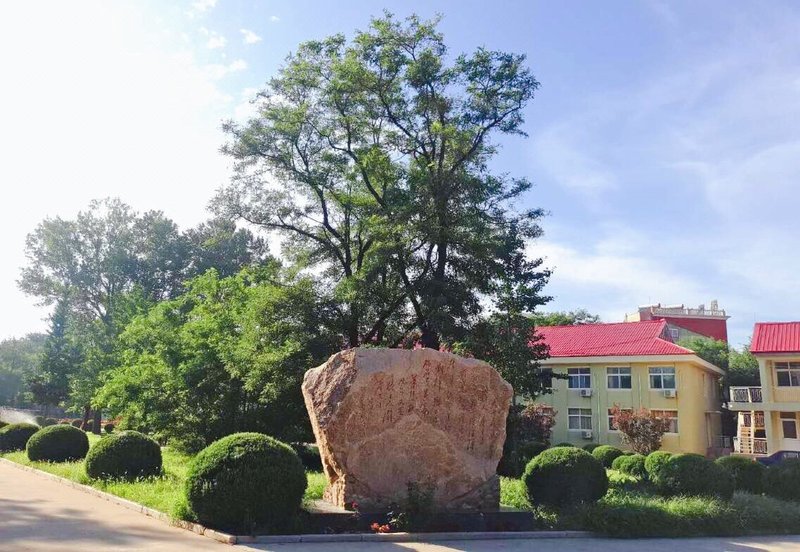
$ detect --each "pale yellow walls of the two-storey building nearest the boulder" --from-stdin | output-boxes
[536,361,721,455]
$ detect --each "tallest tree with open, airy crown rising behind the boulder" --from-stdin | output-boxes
[214,14,547,348]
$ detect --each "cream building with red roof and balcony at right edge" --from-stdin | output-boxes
[728,322,800,464]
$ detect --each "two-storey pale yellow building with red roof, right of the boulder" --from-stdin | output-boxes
[536,319,724,456]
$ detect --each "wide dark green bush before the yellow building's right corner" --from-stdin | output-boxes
[656,454,734,500]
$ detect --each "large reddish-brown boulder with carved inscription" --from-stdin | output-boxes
[303,349,512,511]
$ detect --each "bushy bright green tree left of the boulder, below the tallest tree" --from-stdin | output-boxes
[97,262,341,449]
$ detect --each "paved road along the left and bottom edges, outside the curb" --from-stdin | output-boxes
[0,463,800,552]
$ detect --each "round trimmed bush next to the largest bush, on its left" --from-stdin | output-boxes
[85,431,161,479]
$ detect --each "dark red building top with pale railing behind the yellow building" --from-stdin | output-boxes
[625,300,730,342]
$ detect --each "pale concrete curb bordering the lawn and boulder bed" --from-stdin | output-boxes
[0,458,596,545]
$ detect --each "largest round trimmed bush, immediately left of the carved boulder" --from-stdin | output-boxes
[186,433,307,531]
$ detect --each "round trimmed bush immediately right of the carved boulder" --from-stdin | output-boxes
[522,447,608,506]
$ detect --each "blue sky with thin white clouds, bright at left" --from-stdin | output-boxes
[0,0,800,344]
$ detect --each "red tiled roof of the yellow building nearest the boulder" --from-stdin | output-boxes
[536,320,693,357]
